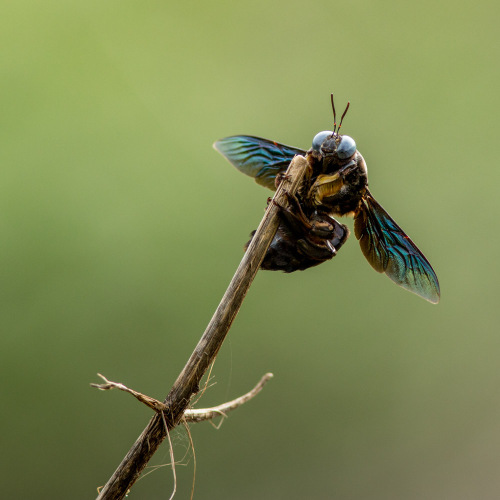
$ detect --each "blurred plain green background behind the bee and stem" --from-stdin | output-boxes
[0,0,500,500]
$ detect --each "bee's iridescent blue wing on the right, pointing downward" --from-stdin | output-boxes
[354,192,440,304]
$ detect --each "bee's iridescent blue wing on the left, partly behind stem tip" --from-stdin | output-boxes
[214,135,305,191]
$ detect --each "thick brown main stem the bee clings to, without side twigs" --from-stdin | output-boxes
[97,155,308,500]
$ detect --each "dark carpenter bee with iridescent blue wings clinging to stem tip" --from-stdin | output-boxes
[214,94,440,304]
